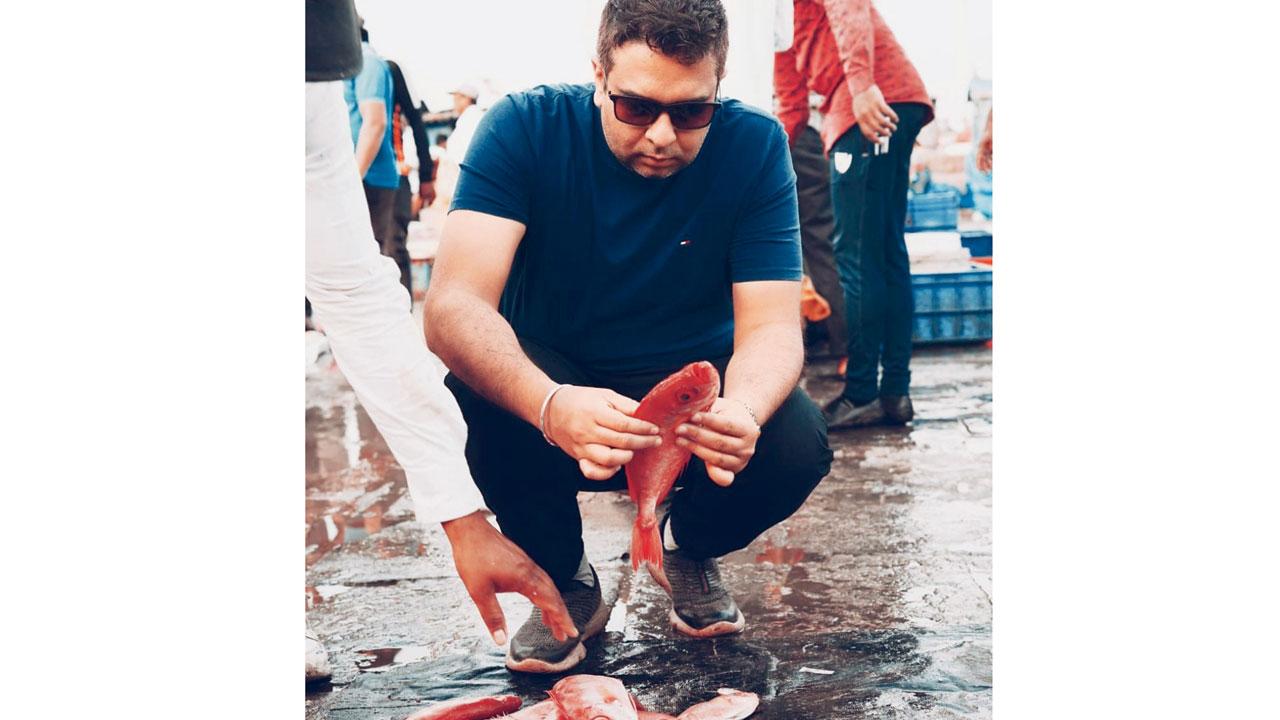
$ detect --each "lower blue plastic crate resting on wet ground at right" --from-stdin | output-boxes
[911,266,992,345]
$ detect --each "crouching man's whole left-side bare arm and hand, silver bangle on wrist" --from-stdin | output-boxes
[424,210,662,480]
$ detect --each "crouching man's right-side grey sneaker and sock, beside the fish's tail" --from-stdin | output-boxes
[649,515,746,638]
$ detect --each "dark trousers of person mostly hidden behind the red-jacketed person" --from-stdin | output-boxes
[791,126,849,355]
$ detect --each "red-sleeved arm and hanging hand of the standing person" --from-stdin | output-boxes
[823,0,897,142]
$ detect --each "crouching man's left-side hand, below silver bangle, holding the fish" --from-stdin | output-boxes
[547,386,662,480]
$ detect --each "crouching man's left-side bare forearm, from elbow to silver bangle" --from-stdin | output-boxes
[425,292,556,427]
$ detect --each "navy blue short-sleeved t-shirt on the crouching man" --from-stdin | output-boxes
[451,85,801,373]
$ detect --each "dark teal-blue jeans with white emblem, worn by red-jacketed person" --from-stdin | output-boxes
[831,102,928,405]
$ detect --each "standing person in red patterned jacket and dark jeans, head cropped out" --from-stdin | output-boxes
[773,0,933,429]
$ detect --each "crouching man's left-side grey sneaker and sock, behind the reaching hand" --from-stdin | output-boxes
[507,568,609,673]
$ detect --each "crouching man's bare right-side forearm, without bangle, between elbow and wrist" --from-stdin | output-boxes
[724,322,804,425]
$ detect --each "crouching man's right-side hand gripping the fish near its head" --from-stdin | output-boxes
[676,397,760,487]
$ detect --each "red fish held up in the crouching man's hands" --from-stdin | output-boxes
[627,361,719,577]
